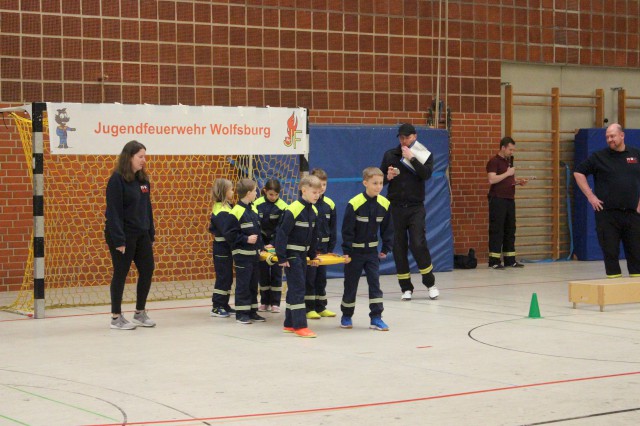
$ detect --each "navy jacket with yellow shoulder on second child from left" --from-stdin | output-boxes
[223,201,264,260]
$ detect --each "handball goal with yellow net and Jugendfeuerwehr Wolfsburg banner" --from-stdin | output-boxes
[0,104,309,317]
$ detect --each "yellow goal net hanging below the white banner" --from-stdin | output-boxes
[0,114,301,314]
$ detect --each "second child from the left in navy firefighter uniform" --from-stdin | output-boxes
[223,179,265,324]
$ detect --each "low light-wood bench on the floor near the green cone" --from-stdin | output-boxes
[569,278,640,312]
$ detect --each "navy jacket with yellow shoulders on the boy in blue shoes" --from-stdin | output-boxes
[342,192,393,256]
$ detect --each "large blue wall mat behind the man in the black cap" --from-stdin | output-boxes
[309,125,453,278]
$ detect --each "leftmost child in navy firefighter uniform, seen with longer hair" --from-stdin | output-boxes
[209,179,236,318]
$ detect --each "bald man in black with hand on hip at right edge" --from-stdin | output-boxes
[573,123,640,278]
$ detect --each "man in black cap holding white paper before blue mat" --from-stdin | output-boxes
[380,123,440,301]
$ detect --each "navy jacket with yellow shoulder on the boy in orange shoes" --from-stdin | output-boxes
[275,198,318,262]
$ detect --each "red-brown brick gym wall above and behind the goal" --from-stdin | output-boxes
[0,0,640,290]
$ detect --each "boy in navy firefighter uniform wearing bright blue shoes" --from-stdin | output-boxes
[340,167,393,331]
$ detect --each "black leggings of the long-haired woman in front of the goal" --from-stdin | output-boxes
[105,231,155,314]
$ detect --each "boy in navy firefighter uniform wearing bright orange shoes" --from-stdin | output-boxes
[275,176,322,337]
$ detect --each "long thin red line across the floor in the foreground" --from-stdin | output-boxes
[85,371,640,426]
